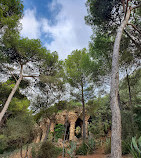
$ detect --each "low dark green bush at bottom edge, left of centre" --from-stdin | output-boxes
[37,141,62,158]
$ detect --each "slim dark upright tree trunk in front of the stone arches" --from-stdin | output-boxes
[81,83,86,141]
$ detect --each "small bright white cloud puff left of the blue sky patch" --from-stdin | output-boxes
[21,9,41,39]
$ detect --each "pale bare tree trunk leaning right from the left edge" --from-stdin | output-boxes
[0,66,23,122]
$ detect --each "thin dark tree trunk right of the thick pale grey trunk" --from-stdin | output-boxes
[126,69,135,136]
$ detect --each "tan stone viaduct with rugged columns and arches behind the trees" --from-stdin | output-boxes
[34,107,90,143]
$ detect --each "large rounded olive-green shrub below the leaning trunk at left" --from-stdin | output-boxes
[3,113,34,151]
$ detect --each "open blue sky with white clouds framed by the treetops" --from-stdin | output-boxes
[21,0,92,60]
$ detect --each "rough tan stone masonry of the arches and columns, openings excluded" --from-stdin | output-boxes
[34,107,90,143]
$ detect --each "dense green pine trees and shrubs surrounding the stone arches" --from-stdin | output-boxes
[0,0,141,158]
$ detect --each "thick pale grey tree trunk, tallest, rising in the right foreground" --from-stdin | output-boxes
[110,9,131,158]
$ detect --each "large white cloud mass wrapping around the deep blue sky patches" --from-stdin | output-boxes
[21,0,92,59]
